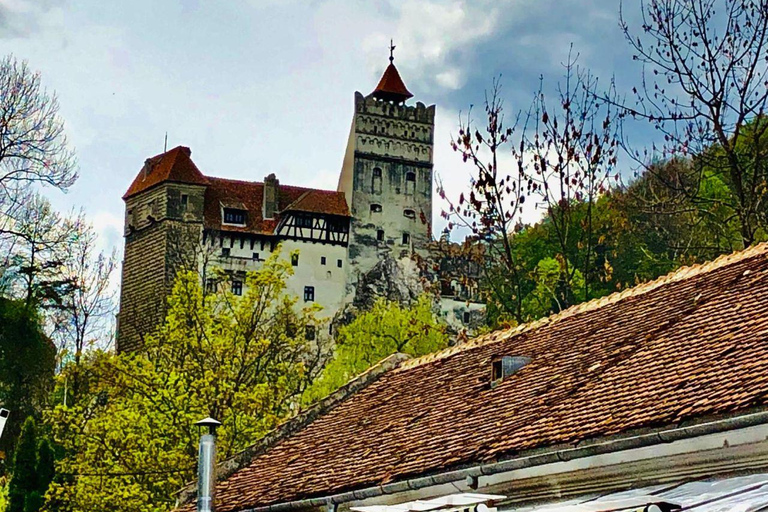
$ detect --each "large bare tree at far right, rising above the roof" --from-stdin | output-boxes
[621,0,768,246]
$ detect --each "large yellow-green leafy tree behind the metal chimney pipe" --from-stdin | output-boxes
[47,255,324,511]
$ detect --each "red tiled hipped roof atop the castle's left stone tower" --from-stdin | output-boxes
[123,146,208,199]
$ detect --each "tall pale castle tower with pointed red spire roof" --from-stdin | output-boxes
[338,56,435,294]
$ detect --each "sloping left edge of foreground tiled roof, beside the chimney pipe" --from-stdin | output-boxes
[177,352,410,507]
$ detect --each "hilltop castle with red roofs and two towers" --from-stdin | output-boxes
[117,54,476,352]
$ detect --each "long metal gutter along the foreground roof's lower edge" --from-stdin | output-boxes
[241,411,768,512]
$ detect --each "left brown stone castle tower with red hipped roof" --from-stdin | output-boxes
[116,146,208,352]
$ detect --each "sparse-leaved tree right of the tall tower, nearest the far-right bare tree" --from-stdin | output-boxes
[521,53,624,309]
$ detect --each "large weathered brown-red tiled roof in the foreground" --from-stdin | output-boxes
[189,245,768,512]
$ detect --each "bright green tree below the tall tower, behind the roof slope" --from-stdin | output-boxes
[304,294,448,403]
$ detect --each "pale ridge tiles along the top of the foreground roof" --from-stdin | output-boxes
[394,242,768,371]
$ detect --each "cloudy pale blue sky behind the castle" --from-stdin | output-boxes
[0,0,656,254]
